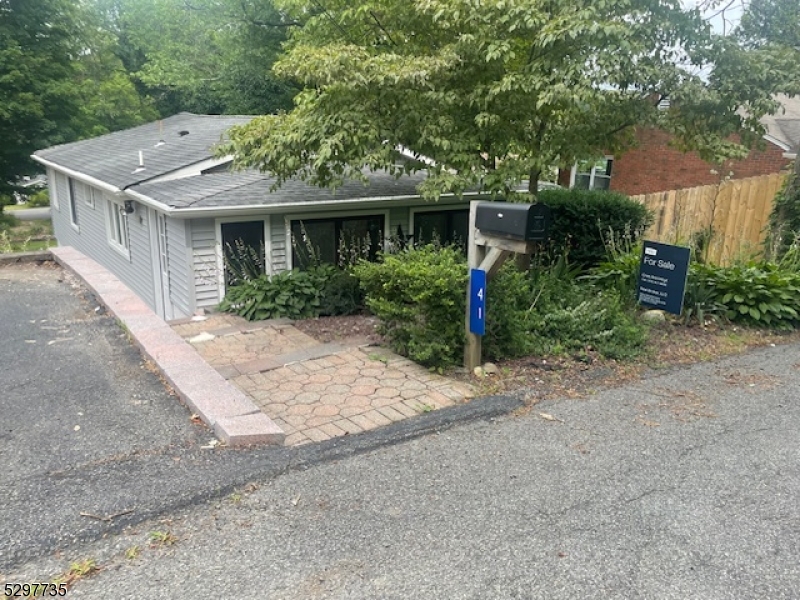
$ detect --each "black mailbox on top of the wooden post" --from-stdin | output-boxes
[475,202,550,242]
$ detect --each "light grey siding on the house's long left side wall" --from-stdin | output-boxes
[52,173,156,310]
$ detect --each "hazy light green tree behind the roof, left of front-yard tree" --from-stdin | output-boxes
[95,0,296,114]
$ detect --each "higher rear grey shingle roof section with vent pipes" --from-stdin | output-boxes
[35,113,253,189]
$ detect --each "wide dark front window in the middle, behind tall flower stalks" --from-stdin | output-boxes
[291,215,385,269]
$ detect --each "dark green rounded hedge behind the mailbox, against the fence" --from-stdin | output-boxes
[538,189,652,268]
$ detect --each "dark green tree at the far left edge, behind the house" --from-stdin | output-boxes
[0,0,81,195]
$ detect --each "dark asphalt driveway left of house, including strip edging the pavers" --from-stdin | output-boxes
[0,262,519,582]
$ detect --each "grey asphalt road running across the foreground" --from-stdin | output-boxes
[7,274,800,600]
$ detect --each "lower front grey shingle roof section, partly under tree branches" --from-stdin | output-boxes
[131,171,426,209]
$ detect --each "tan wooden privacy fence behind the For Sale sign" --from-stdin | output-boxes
[632,173,785,265]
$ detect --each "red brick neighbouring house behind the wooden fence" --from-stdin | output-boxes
[559,96,800,196]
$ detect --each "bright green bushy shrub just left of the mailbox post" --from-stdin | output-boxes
[353,245,467,367]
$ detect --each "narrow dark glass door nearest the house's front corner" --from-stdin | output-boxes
[221,221,266,287]
